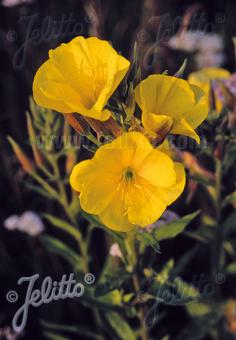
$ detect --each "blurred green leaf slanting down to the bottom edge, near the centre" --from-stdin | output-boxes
[105,312,136,340]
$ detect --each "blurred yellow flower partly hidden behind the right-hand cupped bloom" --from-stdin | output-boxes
[188,67,230,112]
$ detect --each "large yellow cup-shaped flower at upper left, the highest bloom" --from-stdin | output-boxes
[33,37,130,121]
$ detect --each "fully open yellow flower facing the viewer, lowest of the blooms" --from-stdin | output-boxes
[70,132,185,231]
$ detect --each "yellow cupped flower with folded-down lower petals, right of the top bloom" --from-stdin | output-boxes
[135,74,208,143]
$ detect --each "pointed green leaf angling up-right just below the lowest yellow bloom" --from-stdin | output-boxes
[153,211,199,241]
